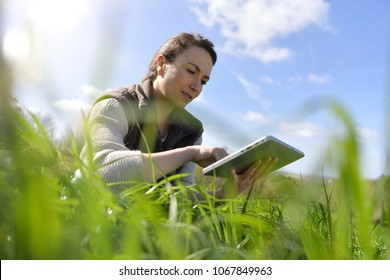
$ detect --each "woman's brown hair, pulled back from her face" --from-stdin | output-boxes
[143,32,217,81]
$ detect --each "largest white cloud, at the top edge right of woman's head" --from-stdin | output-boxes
[192,0,329,63]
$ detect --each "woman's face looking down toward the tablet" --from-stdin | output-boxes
[153,46,213,108]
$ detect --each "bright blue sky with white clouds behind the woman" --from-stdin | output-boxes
[1,0,390,178]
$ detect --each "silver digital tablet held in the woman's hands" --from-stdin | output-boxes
[203,136,305,177]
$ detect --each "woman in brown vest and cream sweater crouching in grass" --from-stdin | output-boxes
[81,33,274,197]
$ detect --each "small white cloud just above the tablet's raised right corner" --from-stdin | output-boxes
[279,122,325,139]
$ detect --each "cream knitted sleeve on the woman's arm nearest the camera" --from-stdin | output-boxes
[81,98,145,186]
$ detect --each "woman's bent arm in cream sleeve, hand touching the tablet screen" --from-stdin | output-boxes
[81,99,227,185]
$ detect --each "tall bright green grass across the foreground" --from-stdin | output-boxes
[0,96,390,260]
